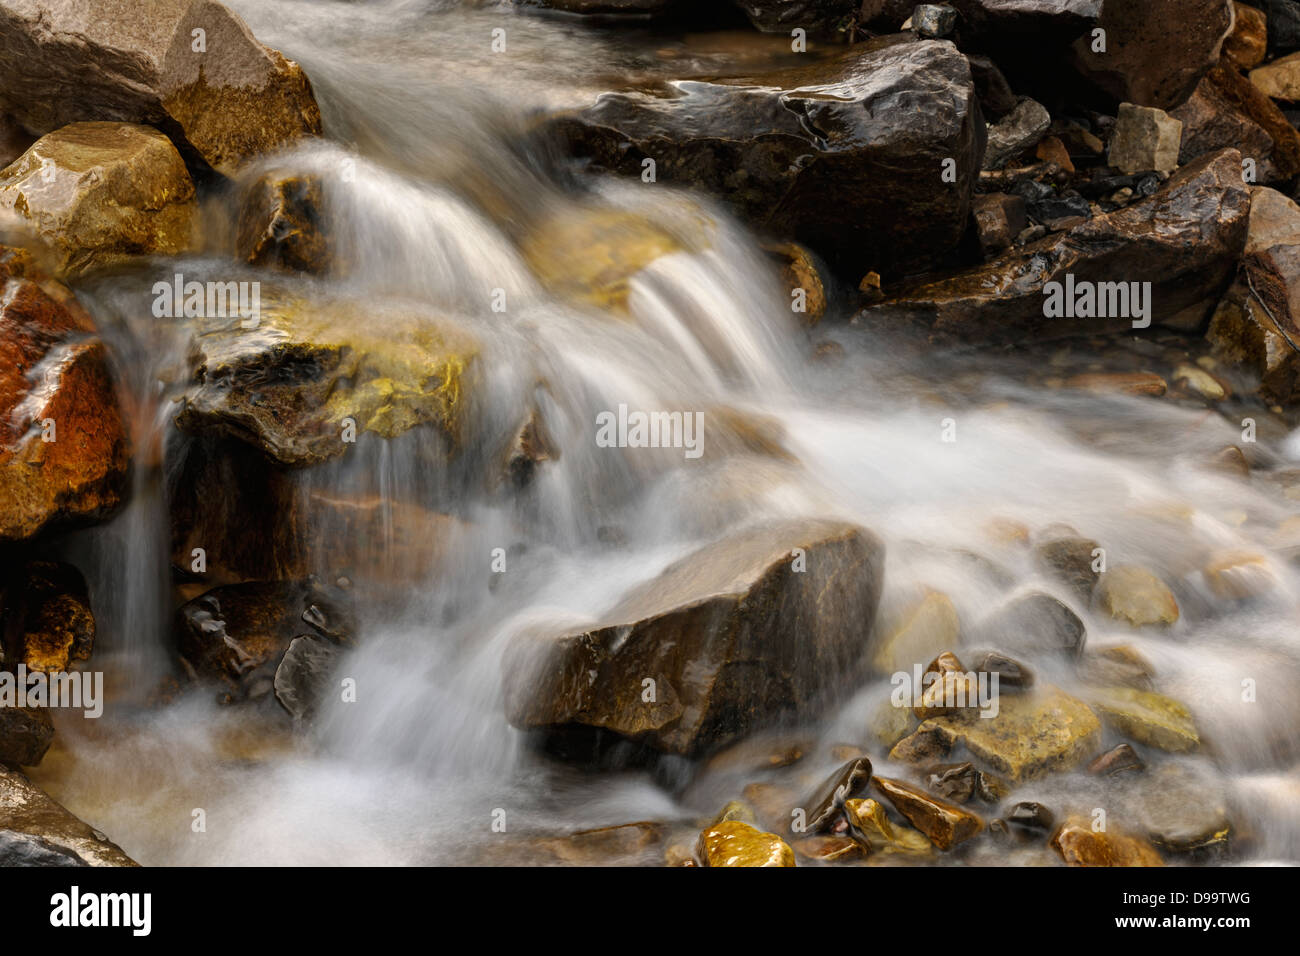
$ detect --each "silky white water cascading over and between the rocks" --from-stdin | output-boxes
[25,0,1300,865]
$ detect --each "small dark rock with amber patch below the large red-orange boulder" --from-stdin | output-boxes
[0,561,95,674]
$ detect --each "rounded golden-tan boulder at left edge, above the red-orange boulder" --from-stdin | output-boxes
[0,122,196,276]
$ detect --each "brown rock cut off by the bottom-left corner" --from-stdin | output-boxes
[0,767,137,866]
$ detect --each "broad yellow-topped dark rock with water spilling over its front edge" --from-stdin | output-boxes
[176,293,478,466]
